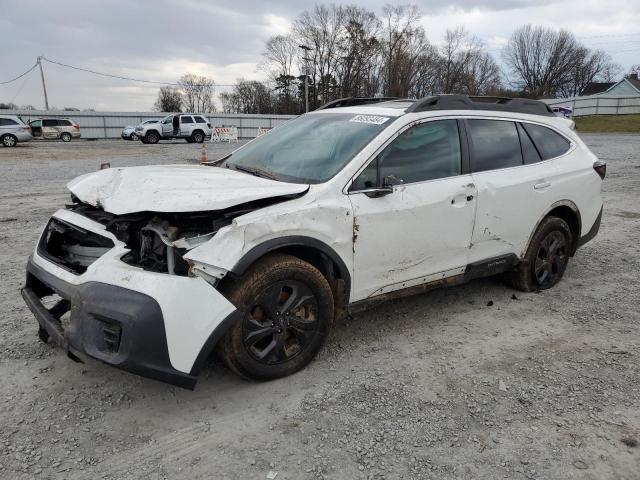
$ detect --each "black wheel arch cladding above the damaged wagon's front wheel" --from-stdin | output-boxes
[231,235,351,303]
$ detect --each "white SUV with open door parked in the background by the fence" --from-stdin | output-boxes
[135,113,211,143]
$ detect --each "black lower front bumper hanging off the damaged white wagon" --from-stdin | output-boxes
[22,259,198,389]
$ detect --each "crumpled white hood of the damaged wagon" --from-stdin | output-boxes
[67,165,309,215]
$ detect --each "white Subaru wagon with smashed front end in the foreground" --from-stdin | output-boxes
[22,96,606,388]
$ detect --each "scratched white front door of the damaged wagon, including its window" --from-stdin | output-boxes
[349,120,476,301]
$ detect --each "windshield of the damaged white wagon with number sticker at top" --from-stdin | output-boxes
[220,113,391,183]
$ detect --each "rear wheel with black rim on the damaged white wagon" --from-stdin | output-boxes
[505,217,573,292]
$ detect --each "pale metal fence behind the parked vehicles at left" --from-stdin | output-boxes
[5,110,295,139]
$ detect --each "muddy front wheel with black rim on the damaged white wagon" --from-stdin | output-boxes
[219,254,334,380]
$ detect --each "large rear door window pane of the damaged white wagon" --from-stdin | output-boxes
[468,120,522,172]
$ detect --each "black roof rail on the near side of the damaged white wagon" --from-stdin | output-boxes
[406,95,554,116]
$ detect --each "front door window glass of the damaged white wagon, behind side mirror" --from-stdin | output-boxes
[378,120,461,184]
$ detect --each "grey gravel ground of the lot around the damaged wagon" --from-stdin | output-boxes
[0,135,640,480]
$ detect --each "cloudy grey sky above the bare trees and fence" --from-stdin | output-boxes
[0,0,640,111]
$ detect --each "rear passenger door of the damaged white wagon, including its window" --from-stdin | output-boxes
[466,118,557,263]
